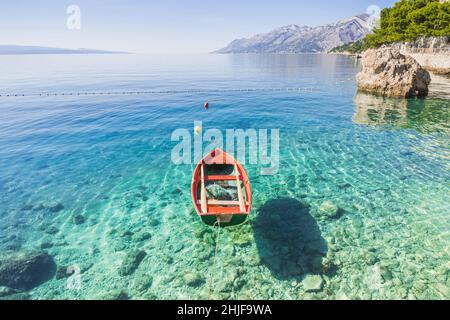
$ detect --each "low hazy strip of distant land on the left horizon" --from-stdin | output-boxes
[0,45,126,55]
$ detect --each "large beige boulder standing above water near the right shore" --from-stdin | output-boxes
[356,47,431,98]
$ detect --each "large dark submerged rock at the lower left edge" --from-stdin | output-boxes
[0,250,56,290]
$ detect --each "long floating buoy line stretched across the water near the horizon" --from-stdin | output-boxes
[0,87,317,97]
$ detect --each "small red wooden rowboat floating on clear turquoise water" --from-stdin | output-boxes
[191,149,252,227]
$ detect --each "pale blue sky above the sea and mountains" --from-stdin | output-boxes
[0,0,395,53]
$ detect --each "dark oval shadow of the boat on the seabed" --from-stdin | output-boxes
[253,198,330,280]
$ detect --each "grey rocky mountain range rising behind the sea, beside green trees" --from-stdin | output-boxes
[214,14,373,53]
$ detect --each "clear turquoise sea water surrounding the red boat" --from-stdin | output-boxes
[0,55,450,299]
